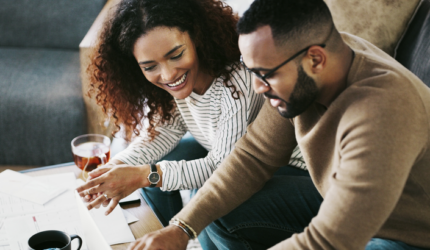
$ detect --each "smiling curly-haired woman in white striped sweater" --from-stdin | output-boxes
[78,0,304,246]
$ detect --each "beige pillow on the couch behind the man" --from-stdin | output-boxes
[325,0,420,55]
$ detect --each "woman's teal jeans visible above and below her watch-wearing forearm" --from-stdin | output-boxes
[142,133,208,226]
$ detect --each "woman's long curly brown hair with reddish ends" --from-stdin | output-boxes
[87,0,240,140]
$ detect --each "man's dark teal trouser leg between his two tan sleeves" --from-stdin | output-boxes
[205,173,323,250]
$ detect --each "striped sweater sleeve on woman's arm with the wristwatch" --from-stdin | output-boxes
[159,75,264,191]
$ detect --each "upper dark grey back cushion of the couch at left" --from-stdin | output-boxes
[0,0,106,49]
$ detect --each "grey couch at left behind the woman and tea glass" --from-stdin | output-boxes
[0,0,106,166]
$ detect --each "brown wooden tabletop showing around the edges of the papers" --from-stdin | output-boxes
[18,163,162,250]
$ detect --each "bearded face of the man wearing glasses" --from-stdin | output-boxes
[239,25,318,118]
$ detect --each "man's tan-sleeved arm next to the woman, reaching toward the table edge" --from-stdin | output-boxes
[175,101,297,233]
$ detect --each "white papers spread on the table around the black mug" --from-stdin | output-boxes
[0,170,137,250]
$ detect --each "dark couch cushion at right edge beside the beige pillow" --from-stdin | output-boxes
[396,0,430,87]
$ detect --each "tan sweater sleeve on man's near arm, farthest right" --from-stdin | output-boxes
[271,84,429,250]
